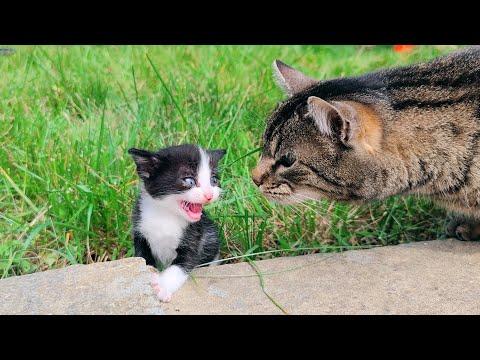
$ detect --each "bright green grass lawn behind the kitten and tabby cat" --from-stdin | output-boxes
[0,46,458,277]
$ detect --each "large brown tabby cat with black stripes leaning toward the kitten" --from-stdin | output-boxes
[252,47,480,240]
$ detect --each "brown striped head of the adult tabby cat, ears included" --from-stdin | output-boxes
[252,61,381,203]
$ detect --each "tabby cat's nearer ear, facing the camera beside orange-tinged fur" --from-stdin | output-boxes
[307,96,357,144]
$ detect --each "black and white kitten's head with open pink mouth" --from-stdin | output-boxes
[128,145,225,222]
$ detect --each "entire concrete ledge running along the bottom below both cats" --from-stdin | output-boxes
[0,240,480,314]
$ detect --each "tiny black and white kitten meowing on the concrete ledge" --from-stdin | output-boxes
[128,145,225,302]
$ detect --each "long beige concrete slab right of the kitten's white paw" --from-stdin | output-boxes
[164,240,480,314]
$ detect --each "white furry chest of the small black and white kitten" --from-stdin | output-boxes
[138,197,187,266]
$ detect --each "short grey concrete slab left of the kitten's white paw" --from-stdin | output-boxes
[0,258,163,315]
